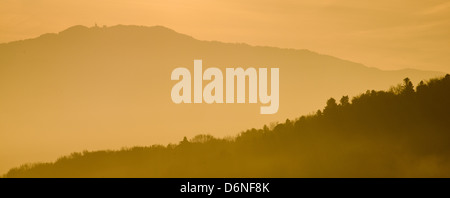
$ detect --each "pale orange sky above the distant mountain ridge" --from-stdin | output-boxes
[0,0,450,72]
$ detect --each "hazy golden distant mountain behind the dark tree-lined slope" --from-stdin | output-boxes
[0,25,442,175]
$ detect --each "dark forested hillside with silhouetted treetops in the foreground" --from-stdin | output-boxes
[5,75,450,177]
